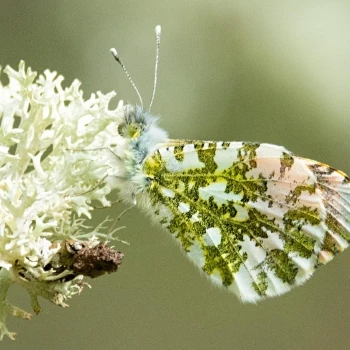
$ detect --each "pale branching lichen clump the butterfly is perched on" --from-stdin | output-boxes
[0,62,123,339]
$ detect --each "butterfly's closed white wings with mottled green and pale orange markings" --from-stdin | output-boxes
[143,142,350,302]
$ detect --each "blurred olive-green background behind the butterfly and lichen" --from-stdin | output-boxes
[0,0,350,350]
